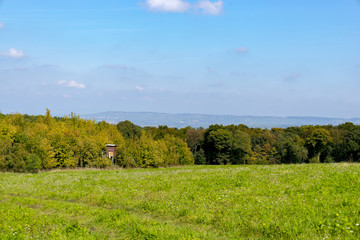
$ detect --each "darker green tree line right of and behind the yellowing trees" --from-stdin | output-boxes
[117,121,360,165]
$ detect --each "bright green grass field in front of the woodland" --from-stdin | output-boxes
[0,164,360,239]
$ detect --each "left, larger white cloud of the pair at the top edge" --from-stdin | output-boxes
[146,0,191,12]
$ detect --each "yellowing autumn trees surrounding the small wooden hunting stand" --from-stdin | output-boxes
[0,110,194,172]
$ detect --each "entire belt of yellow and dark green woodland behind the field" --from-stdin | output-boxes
[0,110,360,172]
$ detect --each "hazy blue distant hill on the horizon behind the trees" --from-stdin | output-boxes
[81,111,360,129]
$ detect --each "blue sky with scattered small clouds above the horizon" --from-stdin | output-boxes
[0,0,360,118]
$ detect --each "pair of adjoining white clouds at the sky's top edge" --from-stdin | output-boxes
[146,0,224,15]
